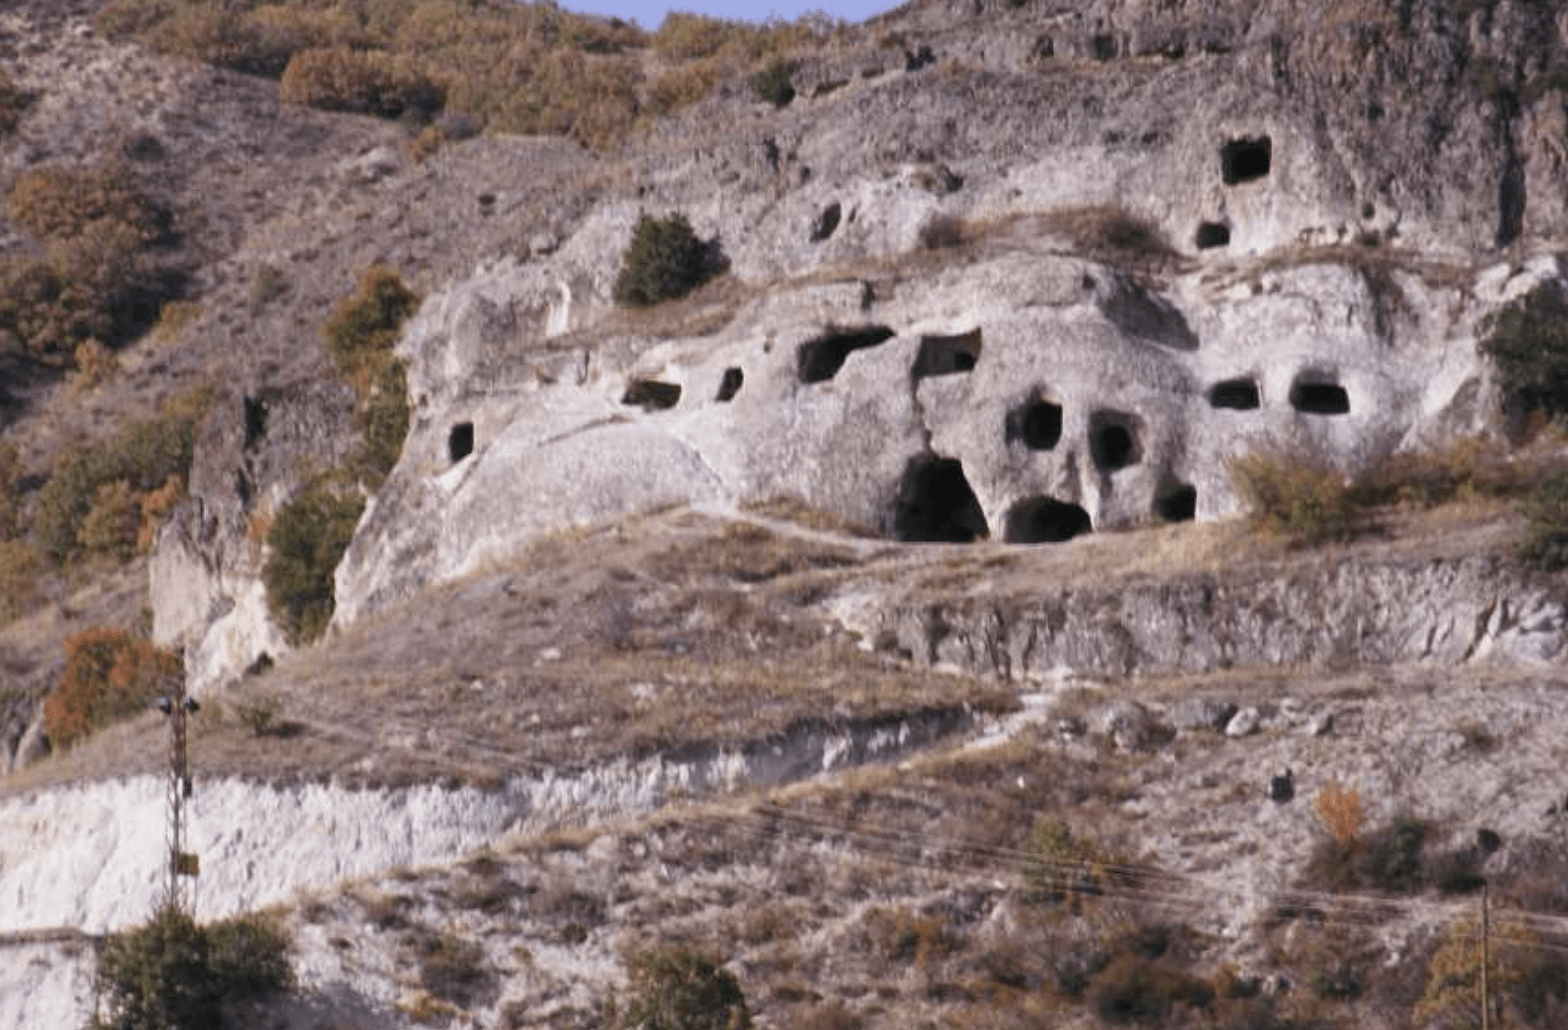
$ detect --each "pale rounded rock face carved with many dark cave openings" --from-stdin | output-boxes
[327,242,1555,624]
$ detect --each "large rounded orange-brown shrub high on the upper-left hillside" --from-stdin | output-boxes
[278,47,445,121]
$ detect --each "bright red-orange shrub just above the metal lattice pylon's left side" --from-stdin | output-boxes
[44,627,183,748]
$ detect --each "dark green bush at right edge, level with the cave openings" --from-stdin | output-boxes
[1480,282,1568,425]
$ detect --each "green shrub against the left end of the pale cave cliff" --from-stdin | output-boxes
[262,480,365,646]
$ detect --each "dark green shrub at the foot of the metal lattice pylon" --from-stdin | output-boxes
[94,906,293,1030]
